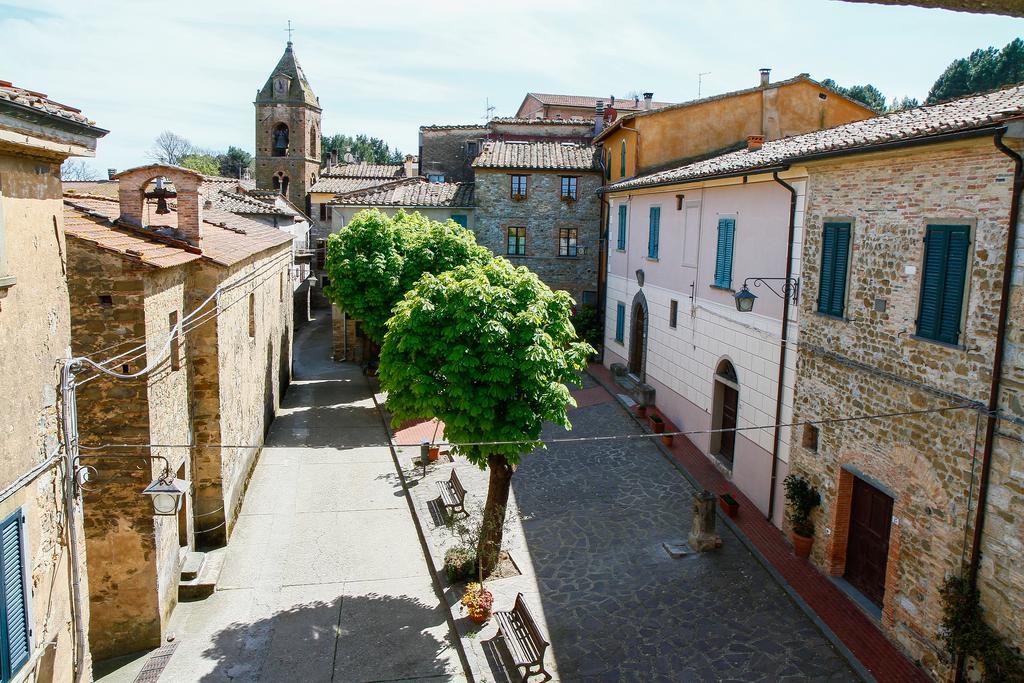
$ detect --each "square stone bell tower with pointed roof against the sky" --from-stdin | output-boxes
[254,40,321,212]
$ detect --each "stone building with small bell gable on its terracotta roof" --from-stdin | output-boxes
[65,165,293,658]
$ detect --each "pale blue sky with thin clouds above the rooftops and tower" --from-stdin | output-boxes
[0,0,1024,175]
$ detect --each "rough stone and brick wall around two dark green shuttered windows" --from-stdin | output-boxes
[791,138,1024,678]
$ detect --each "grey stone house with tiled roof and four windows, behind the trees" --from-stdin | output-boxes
[473,142,601,304]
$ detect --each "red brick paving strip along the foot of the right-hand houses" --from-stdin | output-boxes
[588,364,931,682]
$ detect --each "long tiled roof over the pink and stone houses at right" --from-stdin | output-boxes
[604,84,1024,191]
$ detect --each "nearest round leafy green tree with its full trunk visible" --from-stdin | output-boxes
[380,258,593,577]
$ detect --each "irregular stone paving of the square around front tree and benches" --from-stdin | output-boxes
[385,377,869,681]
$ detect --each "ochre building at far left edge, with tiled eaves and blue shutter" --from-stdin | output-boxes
[0,81,106,681]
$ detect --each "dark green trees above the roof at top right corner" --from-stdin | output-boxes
[925,38,1024,104]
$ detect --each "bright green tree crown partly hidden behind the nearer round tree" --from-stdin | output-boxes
[325,209,493,343]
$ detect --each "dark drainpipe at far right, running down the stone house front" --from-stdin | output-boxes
[956,122,1024,680]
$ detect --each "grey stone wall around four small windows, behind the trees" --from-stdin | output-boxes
[474,169,601,303]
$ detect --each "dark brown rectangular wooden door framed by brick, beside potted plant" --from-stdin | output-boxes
[846,477,893,607]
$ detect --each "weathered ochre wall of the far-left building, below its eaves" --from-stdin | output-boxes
[0,153,91,680]
